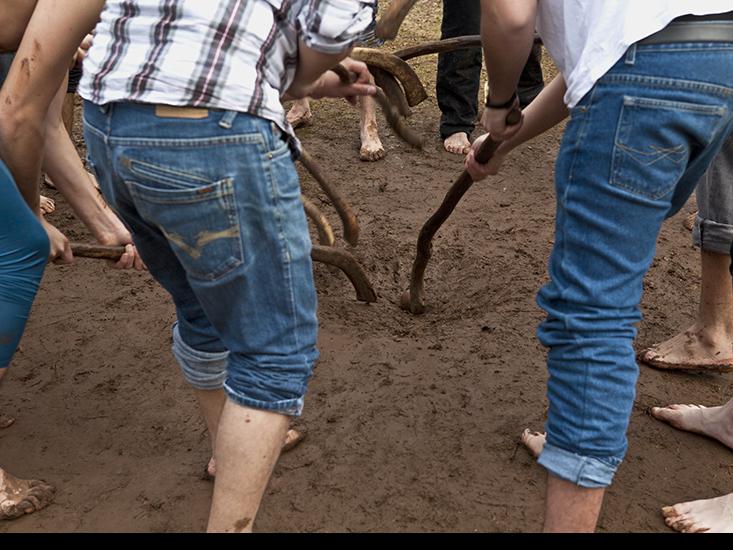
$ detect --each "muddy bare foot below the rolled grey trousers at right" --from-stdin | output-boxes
[639,324,733,372]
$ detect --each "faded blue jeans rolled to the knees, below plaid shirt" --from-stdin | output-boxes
[84,102,318,415]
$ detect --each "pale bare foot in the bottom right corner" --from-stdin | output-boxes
[662,493,733,533]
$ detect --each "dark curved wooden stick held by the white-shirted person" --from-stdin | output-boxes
[400,109,522,315]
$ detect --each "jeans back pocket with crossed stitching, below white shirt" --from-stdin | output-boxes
[611,96,725,200]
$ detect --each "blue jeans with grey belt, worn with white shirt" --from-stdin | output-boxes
[537,43,733,487]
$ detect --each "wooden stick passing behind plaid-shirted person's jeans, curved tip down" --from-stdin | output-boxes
[71,243,377,303]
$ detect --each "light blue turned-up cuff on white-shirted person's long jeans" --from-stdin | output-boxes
[537,443,621,489]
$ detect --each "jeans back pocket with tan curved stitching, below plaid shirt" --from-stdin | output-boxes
[125,158,244,281]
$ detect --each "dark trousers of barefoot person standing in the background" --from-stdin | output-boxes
[436,0,544,139]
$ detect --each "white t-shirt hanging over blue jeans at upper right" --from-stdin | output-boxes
[537,0,733,108]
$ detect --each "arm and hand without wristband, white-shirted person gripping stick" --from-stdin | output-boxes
[466,75,568,181]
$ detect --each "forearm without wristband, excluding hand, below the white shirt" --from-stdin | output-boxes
[501,76,568,153]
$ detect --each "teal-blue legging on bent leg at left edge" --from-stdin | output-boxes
[0,161,50,369]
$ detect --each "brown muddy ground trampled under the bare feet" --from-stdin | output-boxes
[0,0,733,532]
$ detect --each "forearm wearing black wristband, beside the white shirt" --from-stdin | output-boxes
[481,0,537,103]
